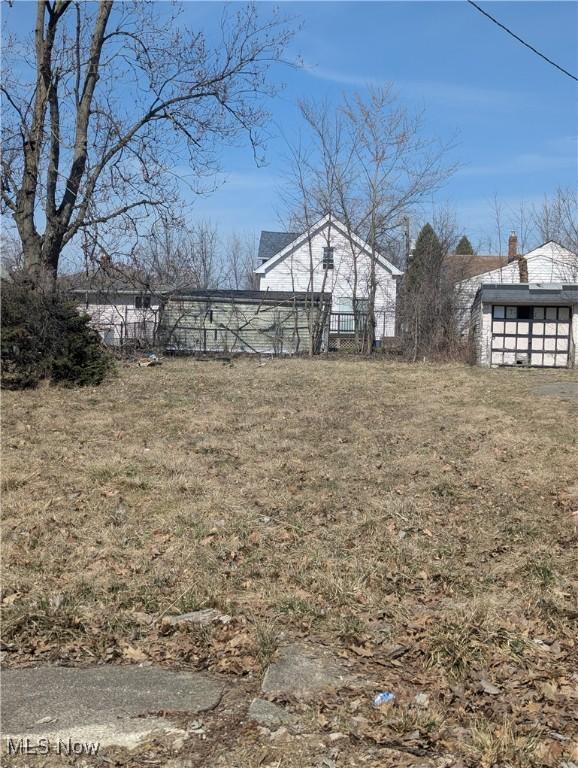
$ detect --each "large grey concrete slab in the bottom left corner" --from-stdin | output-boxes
[2,666,223,747]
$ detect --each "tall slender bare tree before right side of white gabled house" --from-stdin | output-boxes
[286,87,451,353]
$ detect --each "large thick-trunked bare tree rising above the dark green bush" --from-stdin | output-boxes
[2,0,291,282]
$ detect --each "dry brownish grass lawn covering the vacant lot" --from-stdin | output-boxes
[2,359,578,765]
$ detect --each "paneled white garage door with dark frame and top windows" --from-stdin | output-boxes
[492,304,571,368]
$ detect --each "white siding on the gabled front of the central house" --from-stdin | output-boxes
[259,216,397,339]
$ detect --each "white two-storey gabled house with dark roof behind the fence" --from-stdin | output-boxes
[255,215,402,343]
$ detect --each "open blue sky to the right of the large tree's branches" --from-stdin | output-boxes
[181,0,578,249]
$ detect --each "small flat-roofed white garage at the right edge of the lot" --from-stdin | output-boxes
[471,283,578,368]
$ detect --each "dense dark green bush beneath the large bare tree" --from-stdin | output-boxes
[1,281,113,389]
